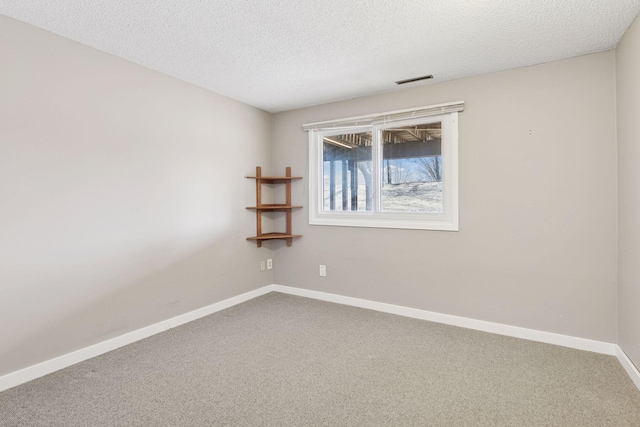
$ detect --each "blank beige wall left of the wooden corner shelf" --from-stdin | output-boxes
[0,16,273,375]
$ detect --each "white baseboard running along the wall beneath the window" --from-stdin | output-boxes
[272,285,617,356]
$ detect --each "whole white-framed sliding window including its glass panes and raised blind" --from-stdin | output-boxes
[304,102,464,231]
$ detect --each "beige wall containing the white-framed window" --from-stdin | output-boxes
[273,52,617,342]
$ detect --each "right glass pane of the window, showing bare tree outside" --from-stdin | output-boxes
[381,122,442,213]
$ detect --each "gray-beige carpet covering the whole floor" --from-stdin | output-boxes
[0,293,640,427]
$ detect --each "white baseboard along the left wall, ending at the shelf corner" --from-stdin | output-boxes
[0,285,273,391]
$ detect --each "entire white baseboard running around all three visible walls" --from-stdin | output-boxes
[0,285,640,391]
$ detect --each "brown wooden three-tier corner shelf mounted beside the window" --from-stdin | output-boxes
[247,166,302,247]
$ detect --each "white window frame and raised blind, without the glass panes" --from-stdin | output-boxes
[303,102,464,231]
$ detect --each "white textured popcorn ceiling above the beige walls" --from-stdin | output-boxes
[0,0,640,112]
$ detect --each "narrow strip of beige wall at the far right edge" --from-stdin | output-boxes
[616,12,640,367]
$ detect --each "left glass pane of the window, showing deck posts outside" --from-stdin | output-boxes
[322,132,373,211]
